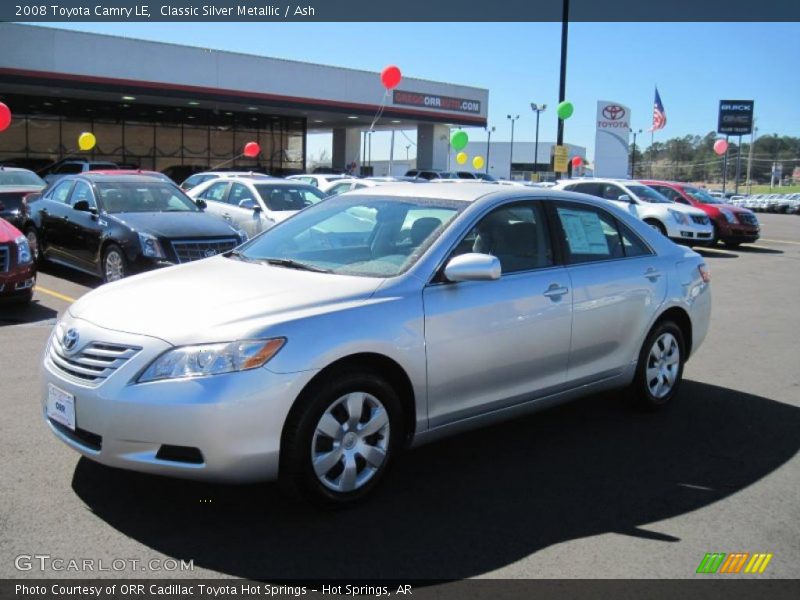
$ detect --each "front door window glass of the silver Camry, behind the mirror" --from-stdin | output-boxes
[454,202,553,274]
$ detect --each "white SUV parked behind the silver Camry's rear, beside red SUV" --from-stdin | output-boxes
[555,179,714,243]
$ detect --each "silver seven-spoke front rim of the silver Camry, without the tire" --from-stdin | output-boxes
[311,392,389,493]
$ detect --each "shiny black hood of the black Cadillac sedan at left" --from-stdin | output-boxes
[105,212,236,238]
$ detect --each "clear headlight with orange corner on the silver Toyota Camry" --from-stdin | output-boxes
[137,338,286,383]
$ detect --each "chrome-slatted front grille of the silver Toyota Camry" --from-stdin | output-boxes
[49,335,141,385]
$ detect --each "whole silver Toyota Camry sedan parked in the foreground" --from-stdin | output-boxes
[42,183,711,503]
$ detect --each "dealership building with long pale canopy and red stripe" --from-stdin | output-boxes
[0,23,489,175]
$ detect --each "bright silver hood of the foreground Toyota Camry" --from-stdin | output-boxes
[69,256,383,345]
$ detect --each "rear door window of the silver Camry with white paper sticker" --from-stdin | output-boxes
[556,203,625,265]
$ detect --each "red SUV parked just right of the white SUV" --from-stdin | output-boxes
[641,180,760,248]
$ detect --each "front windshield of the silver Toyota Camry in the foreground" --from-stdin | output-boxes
[235,196,468,277]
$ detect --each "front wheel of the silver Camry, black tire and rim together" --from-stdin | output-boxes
[279,371,403,508]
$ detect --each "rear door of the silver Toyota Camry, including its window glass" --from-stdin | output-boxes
[549,201,668,386]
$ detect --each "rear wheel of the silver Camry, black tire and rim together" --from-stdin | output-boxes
[629,321,686,411]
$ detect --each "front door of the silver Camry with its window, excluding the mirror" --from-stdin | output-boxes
[423,201,572,427]
